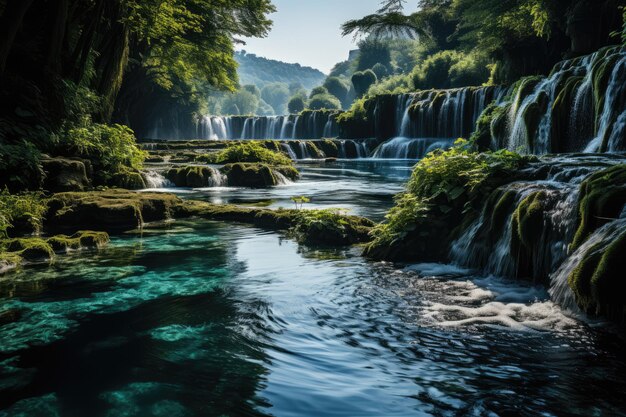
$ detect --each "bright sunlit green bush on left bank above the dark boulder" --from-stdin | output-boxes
[56,118,147,175]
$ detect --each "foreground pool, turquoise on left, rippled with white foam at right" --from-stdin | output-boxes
[0,161,626,416]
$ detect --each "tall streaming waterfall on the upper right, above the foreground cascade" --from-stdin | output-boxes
[491,47,626,154]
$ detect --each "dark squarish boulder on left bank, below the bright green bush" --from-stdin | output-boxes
[41,158,91,193]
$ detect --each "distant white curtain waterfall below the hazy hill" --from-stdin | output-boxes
[195,111,339,140]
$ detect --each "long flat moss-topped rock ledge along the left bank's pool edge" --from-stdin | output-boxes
[44,190,181,232]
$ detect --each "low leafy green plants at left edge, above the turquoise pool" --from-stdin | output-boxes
[0,188,47,238]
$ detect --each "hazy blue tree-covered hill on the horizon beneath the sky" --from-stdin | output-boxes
[235,51,326,90]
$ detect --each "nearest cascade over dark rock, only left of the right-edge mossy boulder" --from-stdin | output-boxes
[450,157,623,280]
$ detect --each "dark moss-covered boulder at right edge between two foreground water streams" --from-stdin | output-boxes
[571,164,626,250]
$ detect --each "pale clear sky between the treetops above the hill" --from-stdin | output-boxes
[238,0,398,74]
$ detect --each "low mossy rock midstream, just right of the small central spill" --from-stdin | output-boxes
[221,163,300,188]
